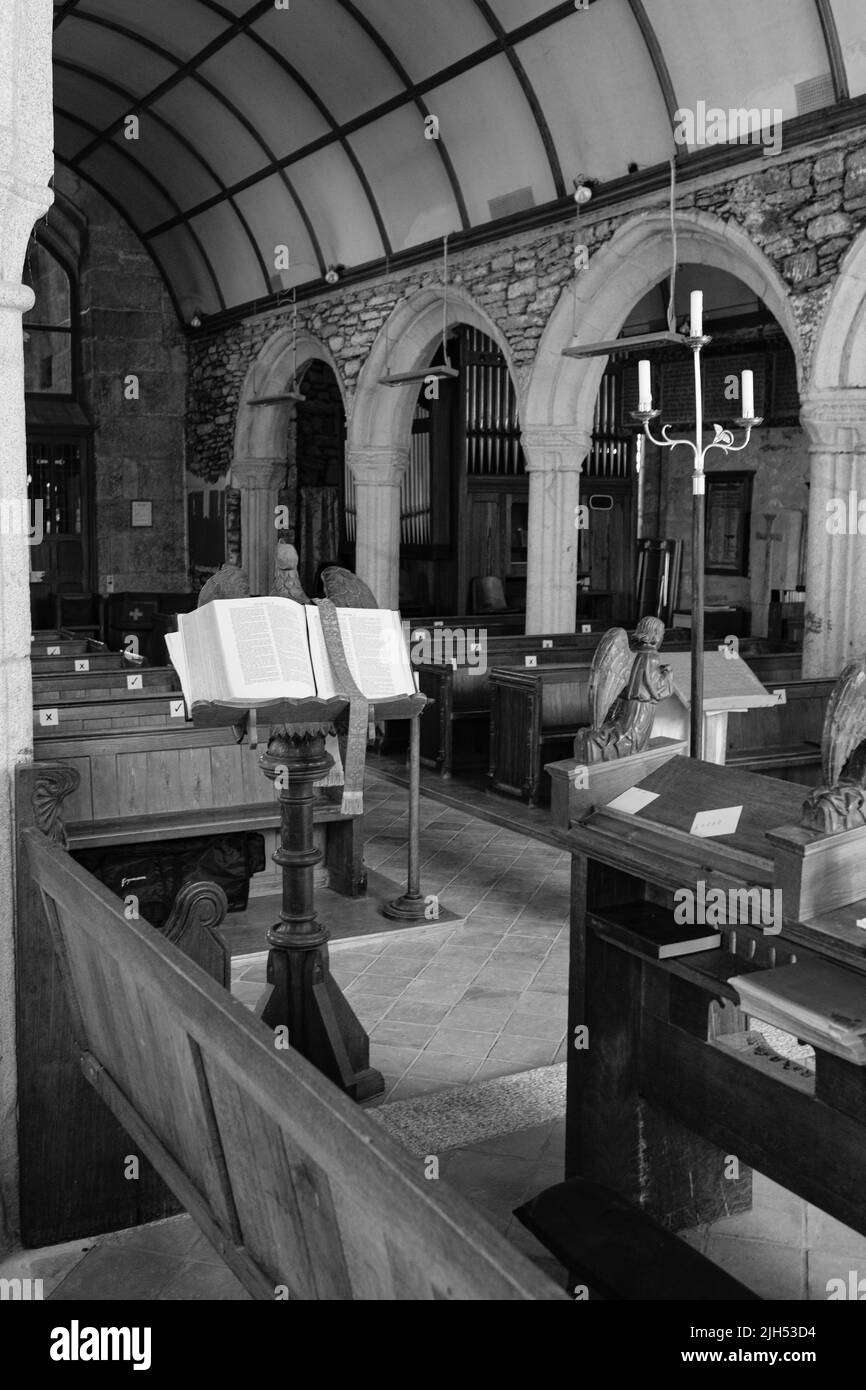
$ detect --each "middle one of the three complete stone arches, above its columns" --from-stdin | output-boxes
[349,285,520,453]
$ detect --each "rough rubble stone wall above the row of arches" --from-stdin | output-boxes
[188,129,866,481]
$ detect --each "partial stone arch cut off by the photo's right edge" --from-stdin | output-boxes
[810,222,866,391]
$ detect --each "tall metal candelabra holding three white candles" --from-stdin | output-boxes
[632,335,762,758]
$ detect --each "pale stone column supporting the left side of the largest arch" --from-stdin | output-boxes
[523,425,591,632]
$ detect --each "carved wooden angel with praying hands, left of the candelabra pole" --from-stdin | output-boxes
[574,617,673,763]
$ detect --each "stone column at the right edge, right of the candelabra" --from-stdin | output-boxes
[801,388,866,677]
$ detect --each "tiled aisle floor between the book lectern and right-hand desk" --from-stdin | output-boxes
[232,783,570,1099]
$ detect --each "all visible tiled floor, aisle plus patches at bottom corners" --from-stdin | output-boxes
[10,778,866,1300]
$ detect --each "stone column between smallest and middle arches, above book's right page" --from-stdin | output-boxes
[348,448,409,609]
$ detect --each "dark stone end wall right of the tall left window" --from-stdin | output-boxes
[57,170,188,594]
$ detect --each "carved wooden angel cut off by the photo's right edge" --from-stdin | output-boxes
[803,657,866,834]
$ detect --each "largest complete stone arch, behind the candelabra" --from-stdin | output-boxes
[525,209,800,431]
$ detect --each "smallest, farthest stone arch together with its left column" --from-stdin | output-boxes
[229,327,346,594]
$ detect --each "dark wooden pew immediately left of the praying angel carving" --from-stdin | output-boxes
[489,662,592,806]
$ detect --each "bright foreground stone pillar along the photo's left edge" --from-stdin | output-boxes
[0,0,54,1251]
